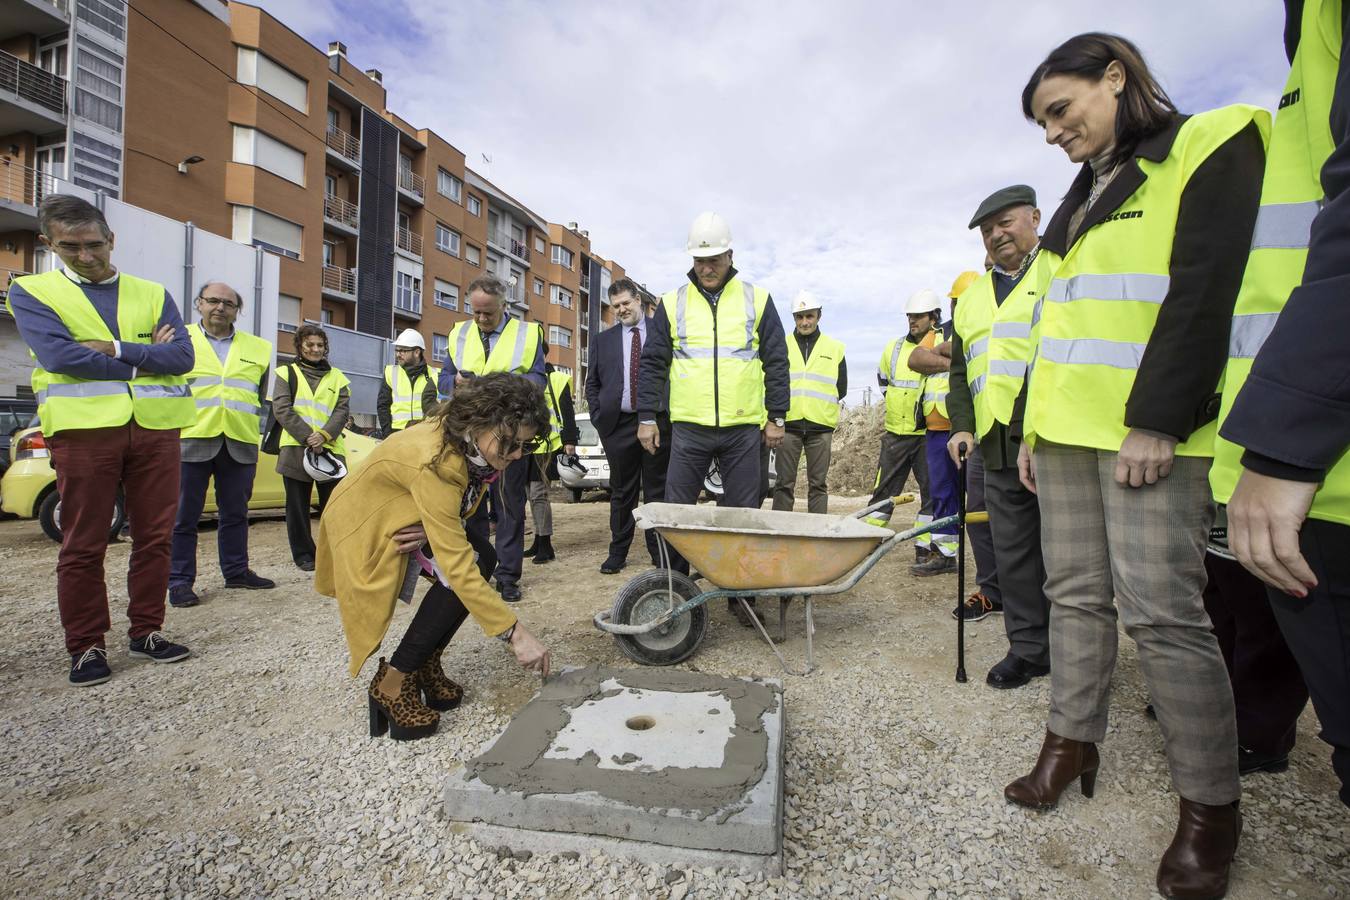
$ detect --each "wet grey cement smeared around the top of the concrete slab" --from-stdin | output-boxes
[463,667,780,818]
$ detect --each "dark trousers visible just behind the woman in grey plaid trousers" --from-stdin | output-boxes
[1204,553,1308,756]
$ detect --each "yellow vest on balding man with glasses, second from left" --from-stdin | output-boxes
[182,324,271,444]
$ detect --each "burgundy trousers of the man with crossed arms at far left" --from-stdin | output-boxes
[47,420,178,653]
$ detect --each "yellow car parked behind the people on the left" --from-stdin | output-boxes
[0,428,379,542]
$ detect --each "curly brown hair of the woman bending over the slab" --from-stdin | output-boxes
[432,372,549,464]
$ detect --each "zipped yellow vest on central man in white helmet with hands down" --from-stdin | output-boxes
[660,278,768,428]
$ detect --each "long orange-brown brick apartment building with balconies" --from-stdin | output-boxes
[0,0,653,394]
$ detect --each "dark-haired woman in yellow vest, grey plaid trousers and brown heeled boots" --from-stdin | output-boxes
[1004,32,1269,897]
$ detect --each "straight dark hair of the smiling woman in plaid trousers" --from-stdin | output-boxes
[1022,31,1177,163]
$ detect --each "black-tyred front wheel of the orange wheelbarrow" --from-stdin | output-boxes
[610,569,707,665]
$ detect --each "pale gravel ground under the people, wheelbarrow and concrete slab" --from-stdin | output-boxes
[0,499,1350,900]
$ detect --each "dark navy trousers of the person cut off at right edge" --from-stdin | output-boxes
[1268,518,1350,806]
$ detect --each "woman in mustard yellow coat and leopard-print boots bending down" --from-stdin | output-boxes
[315,374,549,741]
